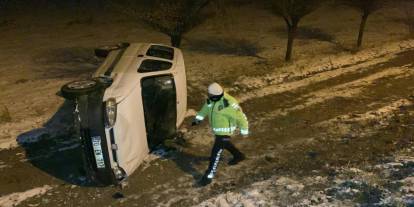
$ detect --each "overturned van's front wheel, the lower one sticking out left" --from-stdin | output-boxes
[61,80,100,99]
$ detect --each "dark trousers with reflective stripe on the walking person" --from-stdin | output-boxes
[205,135,243,179]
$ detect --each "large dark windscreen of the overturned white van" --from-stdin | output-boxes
[141,75,177,150]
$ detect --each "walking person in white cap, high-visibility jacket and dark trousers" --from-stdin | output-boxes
[192,83,249,186]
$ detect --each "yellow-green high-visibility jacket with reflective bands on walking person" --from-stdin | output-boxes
[196,93,249,136]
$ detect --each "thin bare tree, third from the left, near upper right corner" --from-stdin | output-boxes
[343,0,385,48]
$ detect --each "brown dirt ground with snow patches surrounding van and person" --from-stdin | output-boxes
[0,2,414,206]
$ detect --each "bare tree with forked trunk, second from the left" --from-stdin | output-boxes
[271,0,321,61]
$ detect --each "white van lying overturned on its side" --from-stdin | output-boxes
[61,43,187,185]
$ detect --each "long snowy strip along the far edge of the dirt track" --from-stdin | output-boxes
[230,40,414,95]
